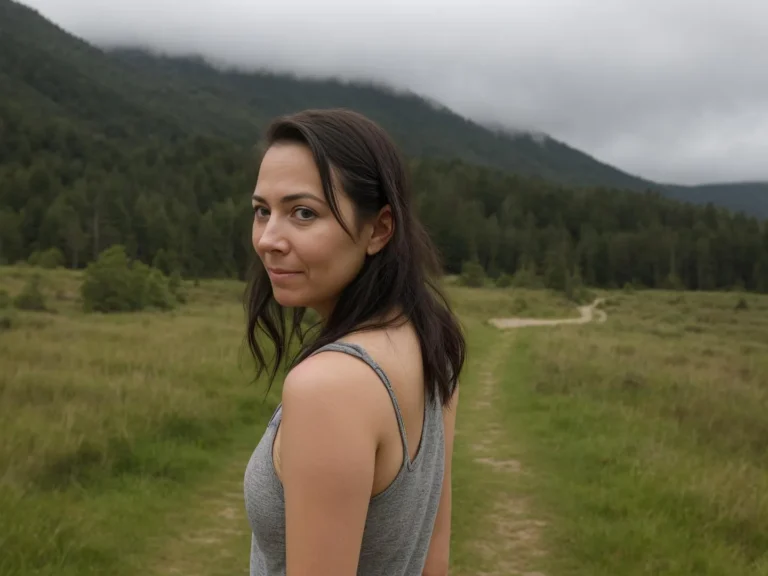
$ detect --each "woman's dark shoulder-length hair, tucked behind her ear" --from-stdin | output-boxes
[246,109,466,405]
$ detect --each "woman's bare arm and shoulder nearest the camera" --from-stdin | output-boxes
[280,354,379,576]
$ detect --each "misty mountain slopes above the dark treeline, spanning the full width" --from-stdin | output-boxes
[0,0,768,217]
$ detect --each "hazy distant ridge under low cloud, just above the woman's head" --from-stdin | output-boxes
[112,50,664,190]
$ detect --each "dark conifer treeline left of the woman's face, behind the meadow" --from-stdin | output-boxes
[0,108,256,277]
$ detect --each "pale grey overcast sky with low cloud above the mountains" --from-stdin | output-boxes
[22,0,768,183]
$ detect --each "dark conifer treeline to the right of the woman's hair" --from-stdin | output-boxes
[413,161,768,292]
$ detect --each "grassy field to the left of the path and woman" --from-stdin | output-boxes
[0,268,279,576]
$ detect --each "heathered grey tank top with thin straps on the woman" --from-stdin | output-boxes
[244,342,445,576]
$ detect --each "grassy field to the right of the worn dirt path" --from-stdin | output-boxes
[496,292,768,576]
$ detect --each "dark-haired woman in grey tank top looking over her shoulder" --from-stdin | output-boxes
[245,110,465,576]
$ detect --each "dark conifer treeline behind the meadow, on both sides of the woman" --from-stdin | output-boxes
[0,109,768,292]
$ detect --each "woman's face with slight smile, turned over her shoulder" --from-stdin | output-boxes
[252,143,376,316]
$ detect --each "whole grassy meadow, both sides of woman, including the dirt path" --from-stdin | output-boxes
[0,267,768,576]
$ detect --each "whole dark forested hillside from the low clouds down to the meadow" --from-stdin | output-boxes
[0,0,768,290]
